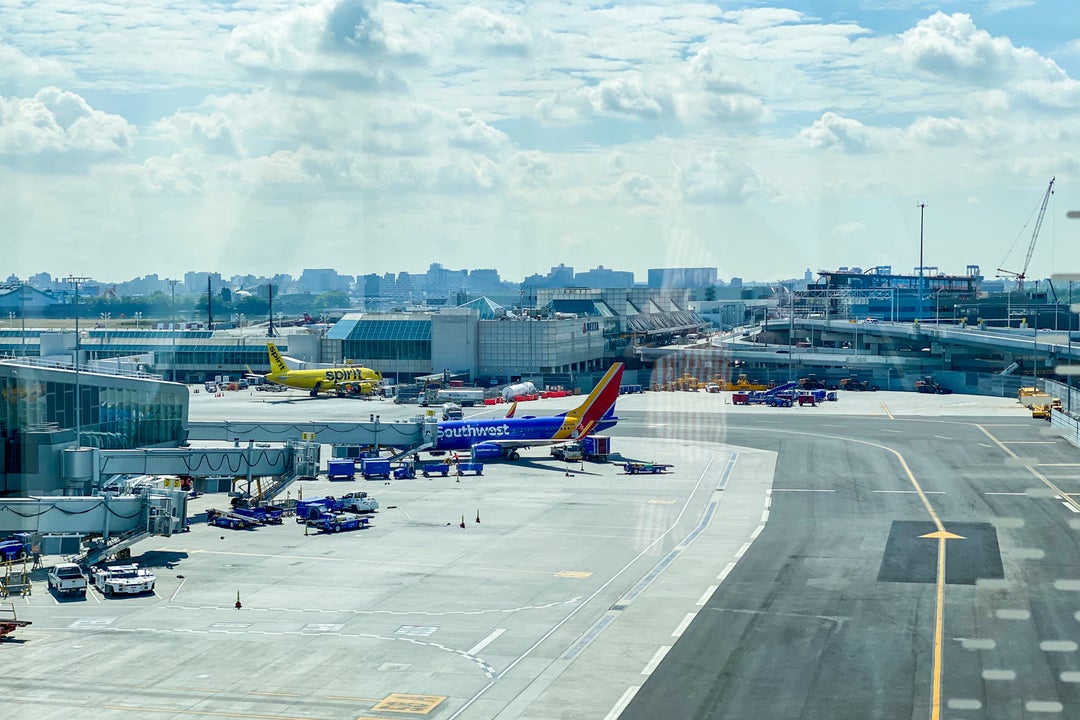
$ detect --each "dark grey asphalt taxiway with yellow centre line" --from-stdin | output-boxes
[621,413,1080,719]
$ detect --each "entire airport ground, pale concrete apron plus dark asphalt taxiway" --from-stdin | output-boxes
[0,391,1080,720]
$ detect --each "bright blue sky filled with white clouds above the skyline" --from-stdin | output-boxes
[0,0,1080,282]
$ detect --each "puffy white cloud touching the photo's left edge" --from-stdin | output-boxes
[0,87,135,158]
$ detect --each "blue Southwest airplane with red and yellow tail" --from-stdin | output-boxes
[432,363,623,460]
